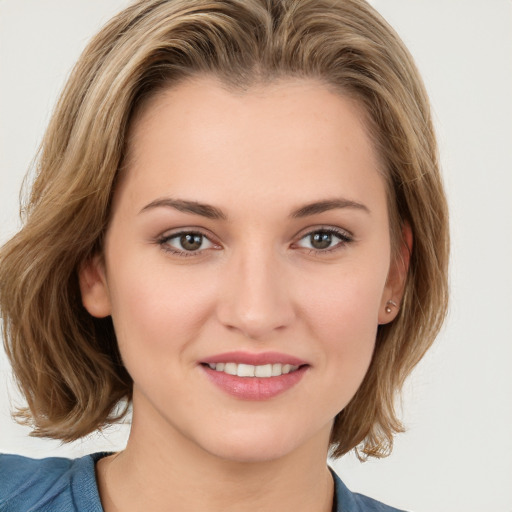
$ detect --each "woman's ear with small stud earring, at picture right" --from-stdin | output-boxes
[379,222,413,325]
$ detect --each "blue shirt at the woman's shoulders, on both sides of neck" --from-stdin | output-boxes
[0,453,403,512]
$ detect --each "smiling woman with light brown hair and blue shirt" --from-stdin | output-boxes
[0,0,448,512]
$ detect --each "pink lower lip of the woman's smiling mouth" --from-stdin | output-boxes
[201,366,308,400]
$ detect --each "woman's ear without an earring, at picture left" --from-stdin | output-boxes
[78,254,111,318]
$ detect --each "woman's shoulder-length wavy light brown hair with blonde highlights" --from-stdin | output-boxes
[0,0,449,458]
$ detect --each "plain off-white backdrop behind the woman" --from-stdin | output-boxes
[0,0,512,512]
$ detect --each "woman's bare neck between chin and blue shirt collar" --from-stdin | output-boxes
[97,400,334,512]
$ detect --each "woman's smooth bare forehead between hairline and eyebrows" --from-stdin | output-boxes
[117,77,383,214]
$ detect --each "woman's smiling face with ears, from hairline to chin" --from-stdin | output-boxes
[80,78,408,461]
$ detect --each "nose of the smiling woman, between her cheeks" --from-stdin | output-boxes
[217,249,295,340]
